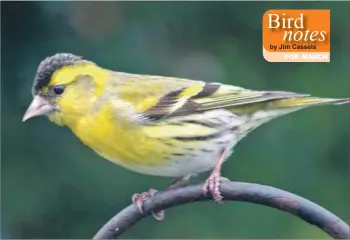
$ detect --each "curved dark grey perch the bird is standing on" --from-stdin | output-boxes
[93,181,350,239]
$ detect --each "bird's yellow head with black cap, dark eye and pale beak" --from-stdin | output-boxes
[23,53,106,125]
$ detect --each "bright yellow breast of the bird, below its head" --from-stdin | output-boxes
[68,105,168,167]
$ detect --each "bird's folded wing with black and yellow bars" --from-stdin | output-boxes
[133,82,306,120]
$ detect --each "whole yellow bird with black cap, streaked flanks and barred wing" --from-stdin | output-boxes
[22,53,350,220]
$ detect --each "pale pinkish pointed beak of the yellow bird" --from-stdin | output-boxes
[22,96,53,122]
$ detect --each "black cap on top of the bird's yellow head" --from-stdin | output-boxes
[32,53,82,95]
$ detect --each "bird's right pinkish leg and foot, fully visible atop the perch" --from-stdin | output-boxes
[202,148,227,203]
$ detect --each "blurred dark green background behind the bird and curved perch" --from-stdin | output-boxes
[1,2,350,238]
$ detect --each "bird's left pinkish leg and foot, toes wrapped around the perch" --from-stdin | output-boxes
[131,174,191,221]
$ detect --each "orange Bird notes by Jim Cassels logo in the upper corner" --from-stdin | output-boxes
[263,9,331,62]
